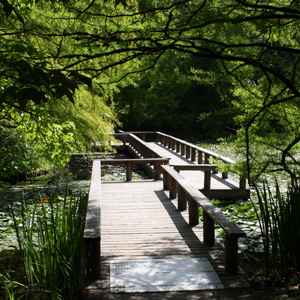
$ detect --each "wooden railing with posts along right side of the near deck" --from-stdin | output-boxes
[162,166,246,275]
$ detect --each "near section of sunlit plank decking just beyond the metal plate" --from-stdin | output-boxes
[101,180,247,287]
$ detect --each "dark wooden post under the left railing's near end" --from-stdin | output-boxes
[84,237,101,279]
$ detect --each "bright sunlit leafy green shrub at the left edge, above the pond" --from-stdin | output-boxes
[0,106,80,178]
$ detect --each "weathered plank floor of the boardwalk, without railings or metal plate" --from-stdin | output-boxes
[81,133,250,299]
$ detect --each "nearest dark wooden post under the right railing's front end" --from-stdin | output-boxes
[225,234,239,275]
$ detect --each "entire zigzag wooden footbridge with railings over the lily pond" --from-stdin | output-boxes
[84,132,249,293]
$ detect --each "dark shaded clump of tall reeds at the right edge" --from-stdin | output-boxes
[256,180,300,283]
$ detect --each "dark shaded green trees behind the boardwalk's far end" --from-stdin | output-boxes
[114,53,230,139]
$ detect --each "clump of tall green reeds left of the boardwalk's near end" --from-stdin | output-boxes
[7,189,86,300]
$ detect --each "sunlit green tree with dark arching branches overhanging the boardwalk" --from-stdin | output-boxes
[2,0,300,182]
